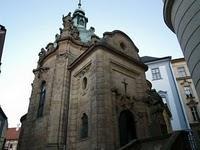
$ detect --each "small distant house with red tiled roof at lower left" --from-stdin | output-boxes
[4,128,20,150]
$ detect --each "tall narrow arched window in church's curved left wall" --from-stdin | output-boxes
[37,81,46,117]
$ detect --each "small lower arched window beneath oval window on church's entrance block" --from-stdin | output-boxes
[80,113,88,138]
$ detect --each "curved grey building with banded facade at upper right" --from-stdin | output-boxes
[163,0,200,97]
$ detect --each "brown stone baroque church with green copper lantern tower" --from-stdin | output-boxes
[18,4,170,150]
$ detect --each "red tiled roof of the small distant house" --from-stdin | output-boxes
[6,128,21,140]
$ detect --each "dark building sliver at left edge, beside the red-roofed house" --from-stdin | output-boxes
[0,107,8,149]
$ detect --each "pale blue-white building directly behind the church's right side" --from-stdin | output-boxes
[141,56,189,130]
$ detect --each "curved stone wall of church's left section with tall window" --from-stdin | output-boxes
[20,41,87,150]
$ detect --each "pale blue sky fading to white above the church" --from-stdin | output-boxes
[0,0,183,127]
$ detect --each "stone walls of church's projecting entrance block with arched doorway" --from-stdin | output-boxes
[67,45,149,150]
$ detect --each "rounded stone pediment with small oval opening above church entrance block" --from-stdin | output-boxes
[102,30,139,60]
